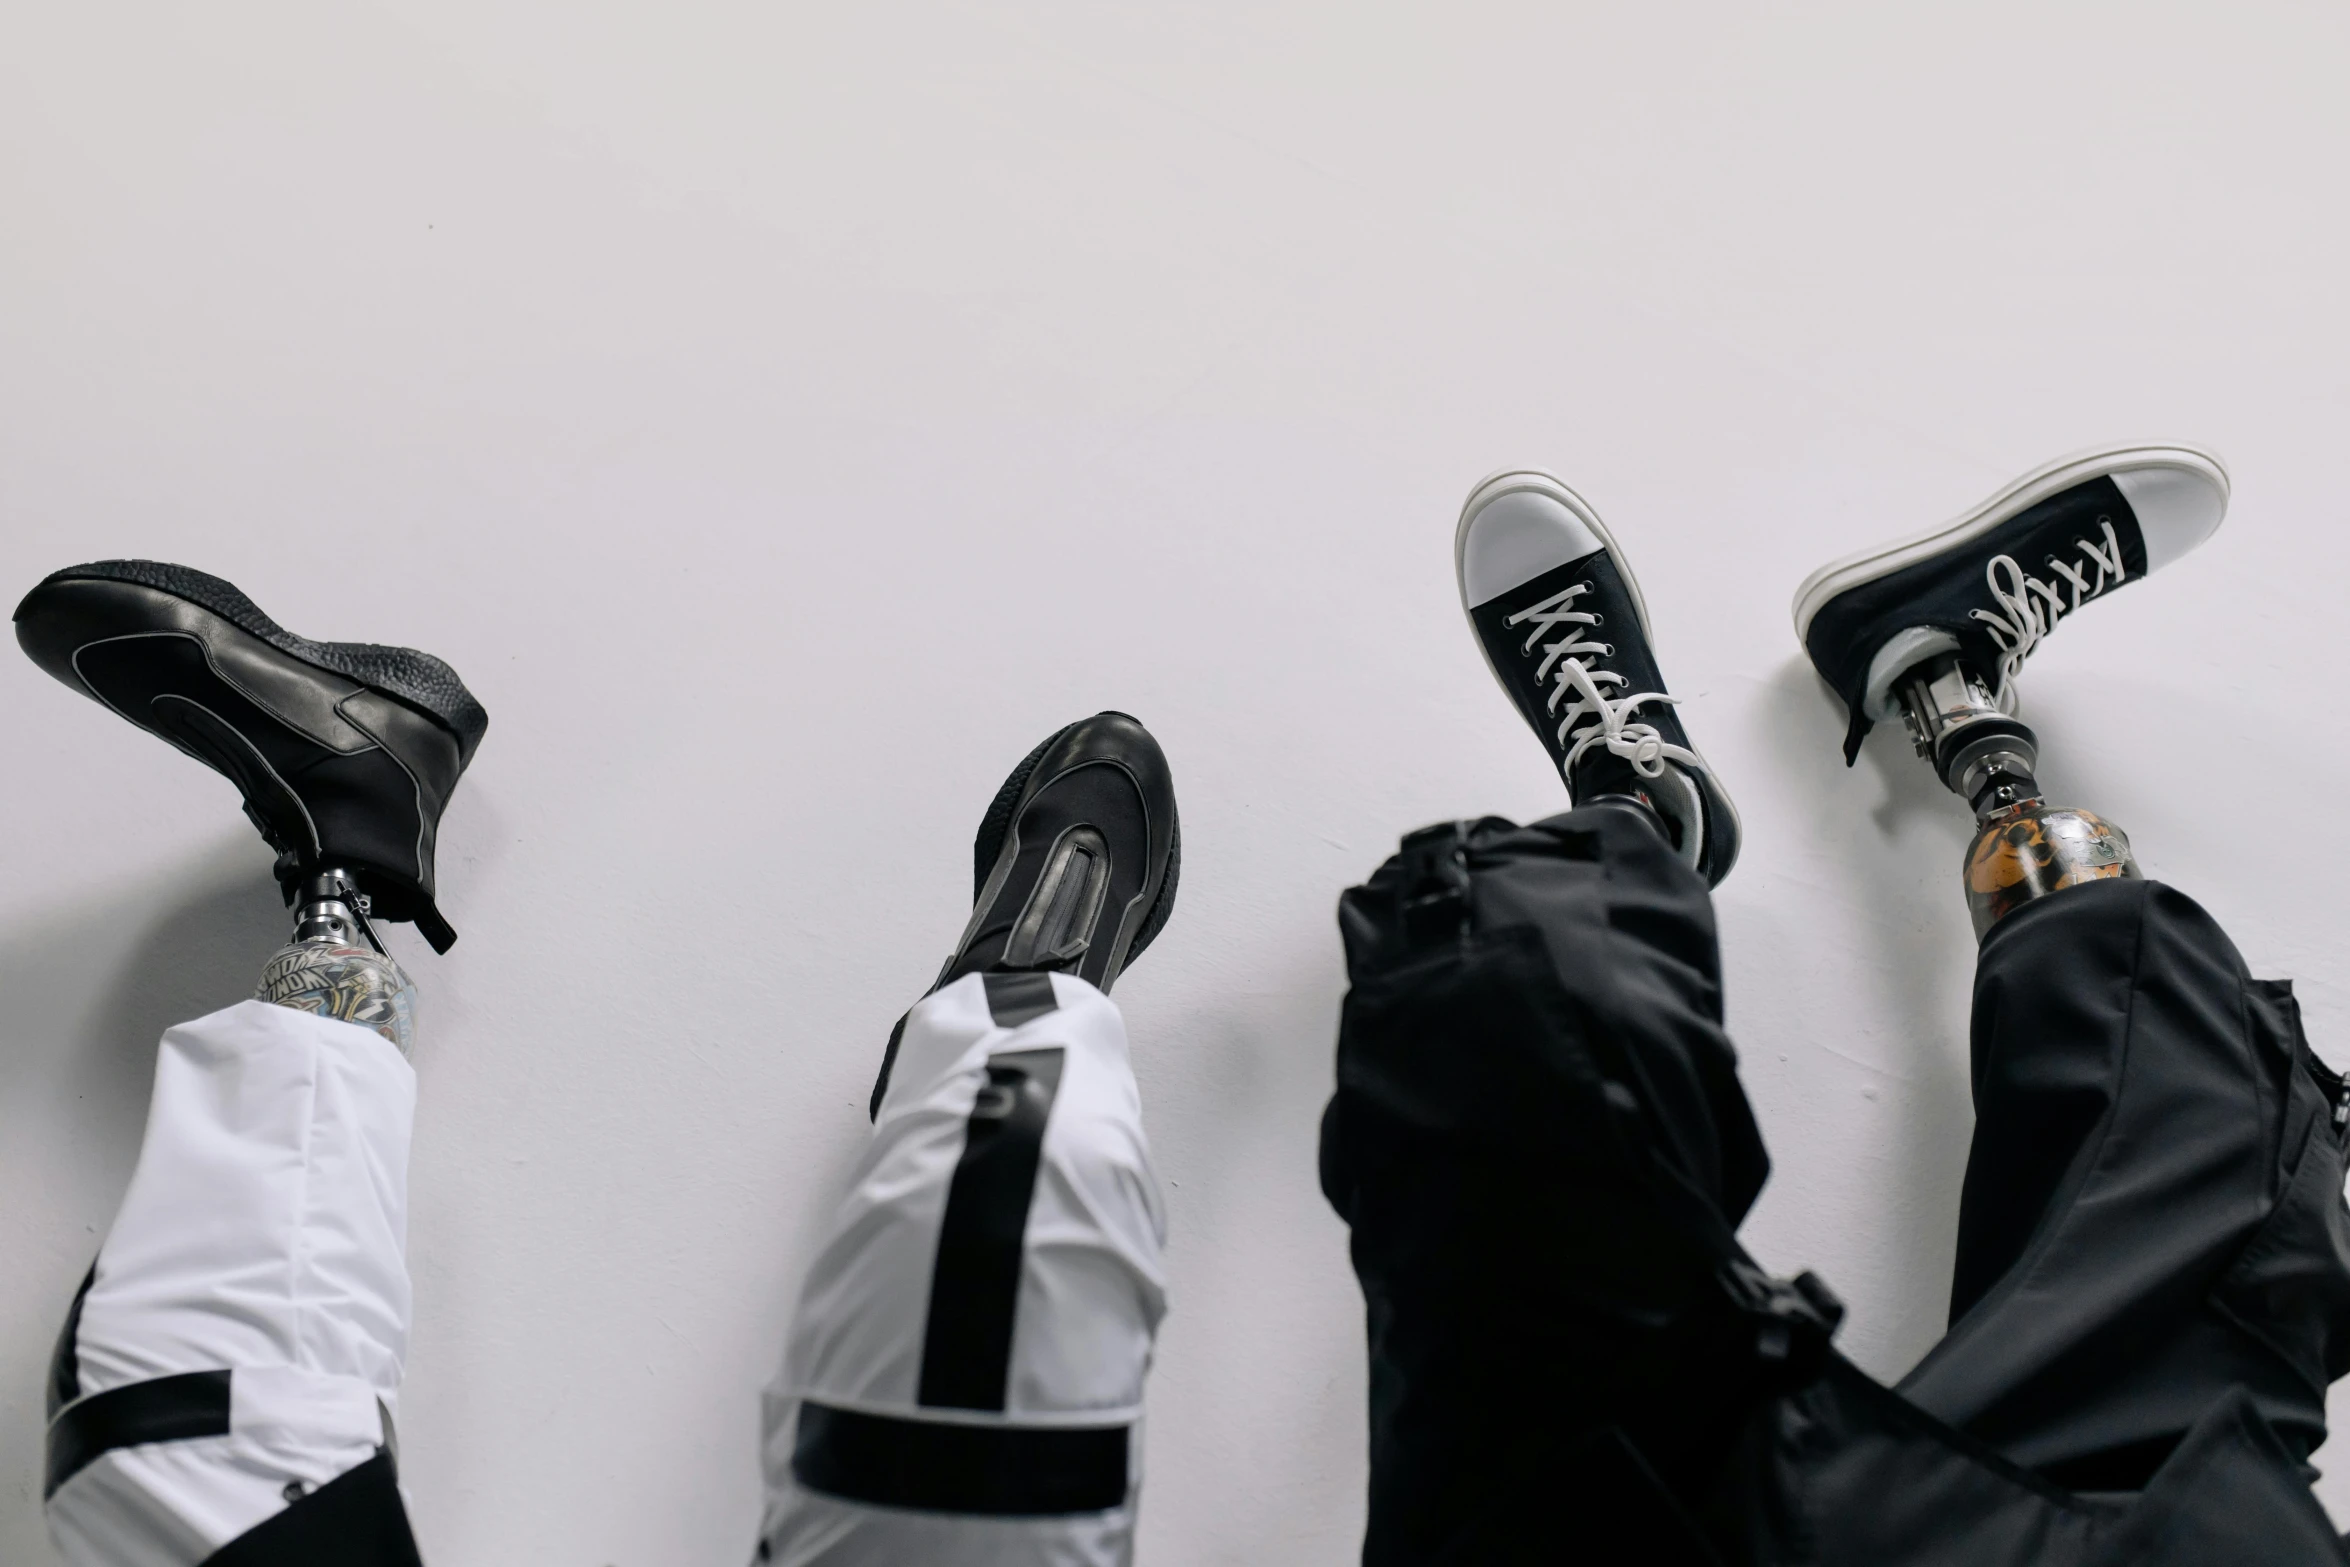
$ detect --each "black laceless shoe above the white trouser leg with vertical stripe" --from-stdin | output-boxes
[870,712,1182,1114]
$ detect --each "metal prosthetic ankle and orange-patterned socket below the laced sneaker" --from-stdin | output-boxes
[1896,653,2139,940]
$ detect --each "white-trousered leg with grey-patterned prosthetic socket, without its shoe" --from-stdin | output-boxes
[45,872,418,1567]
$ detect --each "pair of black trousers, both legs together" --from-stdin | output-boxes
[1323,808,2350,1567]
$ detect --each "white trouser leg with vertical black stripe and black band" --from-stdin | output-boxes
[759,975,1166,1567]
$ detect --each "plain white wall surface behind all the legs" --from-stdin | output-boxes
[0,0,2350,1567]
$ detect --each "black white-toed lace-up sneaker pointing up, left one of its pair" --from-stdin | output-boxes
[1452,470,1739,886]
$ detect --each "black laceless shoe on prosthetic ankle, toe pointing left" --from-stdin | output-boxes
[16,561,489,951]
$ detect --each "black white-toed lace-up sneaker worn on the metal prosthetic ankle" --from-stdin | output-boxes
[1795,444,2228,764]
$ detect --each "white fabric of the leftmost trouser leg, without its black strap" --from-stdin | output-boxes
[49,1001,416,1567]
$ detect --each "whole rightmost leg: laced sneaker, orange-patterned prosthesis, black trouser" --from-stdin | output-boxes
[1781,444,2350,1567]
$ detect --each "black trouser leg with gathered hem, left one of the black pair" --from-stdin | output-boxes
[1323,808,1795,1567]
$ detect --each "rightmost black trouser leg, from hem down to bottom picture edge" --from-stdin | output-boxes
[1781,881,2350,1567]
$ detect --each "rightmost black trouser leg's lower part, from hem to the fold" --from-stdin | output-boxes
[1901,881,2350,1492]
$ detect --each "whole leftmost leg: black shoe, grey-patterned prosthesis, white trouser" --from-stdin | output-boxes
[16,561,489,1567]
